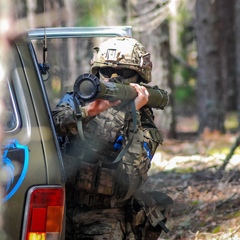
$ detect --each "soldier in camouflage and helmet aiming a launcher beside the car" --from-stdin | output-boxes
[53,37,172,240]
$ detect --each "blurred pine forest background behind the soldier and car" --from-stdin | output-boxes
[1,0,240,239]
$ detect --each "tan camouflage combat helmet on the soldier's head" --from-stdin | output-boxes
[90,37,152,83]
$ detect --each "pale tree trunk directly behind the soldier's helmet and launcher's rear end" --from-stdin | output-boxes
[141,21,176,138]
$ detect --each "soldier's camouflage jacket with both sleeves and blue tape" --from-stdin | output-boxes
[53,93,163,200]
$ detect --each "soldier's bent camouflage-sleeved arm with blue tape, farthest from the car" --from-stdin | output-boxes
[116,108,163,199]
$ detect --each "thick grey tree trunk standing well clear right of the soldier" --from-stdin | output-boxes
[196,0,225,133]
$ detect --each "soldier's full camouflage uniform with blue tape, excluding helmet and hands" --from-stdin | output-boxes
[53,36,171,240]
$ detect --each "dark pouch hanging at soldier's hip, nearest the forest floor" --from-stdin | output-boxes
[131,190,173,239]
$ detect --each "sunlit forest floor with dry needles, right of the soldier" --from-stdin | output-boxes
[145,114,240,240]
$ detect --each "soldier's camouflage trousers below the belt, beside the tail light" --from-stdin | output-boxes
[65,208,136,240]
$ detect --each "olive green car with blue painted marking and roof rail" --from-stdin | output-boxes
[0,26,132,240]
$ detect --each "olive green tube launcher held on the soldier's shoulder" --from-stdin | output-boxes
[73,73,169,109]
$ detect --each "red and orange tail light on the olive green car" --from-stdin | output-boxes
[23,186,65,240]
